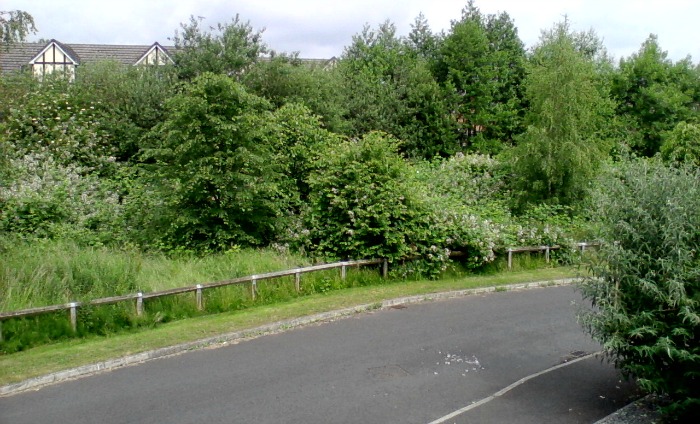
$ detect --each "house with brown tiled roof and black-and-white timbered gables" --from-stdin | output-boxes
[0,40,174,80]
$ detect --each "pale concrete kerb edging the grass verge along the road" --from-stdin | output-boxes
[0,278,578,396]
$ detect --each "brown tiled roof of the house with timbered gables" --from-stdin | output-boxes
[0,40,175,73]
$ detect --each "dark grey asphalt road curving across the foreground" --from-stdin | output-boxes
[0,287,634,424]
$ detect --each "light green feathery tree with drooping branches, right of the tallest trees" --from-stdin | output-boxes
[510,21,612,204]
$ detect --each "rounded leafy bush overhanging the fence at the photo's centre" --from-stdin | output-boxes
[307,132,428,261]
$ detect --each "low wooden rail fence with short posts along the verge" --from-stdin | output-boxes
[0,243,599,341]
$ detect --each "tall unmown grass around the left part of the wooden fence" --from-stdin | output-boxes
[0,241,383,353]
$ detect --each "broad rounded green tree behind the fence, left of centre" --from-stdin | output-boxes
[150,73,295,251]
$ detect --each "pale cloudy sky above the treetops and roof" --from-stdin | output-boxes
[5,0,700,63]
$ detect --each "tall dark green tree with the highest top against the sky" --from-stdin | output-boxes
[434,0,525,153]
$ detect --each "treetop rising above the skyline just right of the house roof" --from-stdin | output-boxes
[172,15,269,80]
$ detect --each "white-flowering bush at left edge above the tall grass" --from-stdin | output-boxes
[0,153,121,244]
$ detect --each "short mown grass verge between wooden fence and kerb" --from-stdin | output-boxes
[0,268,576,385]
